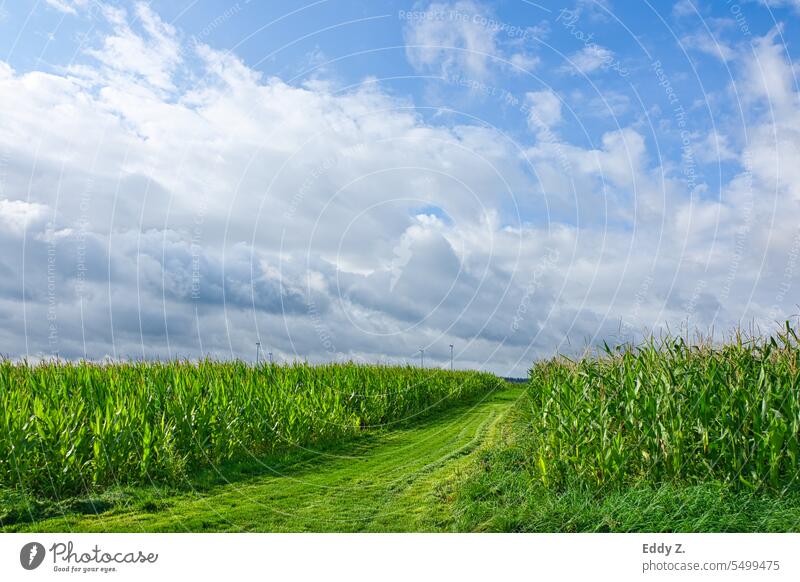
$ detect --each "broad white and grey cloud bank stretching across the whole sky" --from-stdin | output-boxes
[0,5,800,373]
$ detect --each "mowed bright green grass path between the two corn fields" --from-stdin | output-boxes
[12,384,523,532]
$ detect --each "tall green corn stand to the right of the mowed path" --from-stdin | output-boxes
[529,325,800,491]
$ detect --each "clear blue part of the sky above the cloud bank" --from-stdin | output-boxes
[0,0,798,145]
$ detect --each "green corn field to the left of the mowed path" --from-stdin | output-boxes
[0,361,501,496]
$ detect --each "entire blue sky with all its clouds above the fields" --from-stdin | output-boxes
[0,0,800,374]
